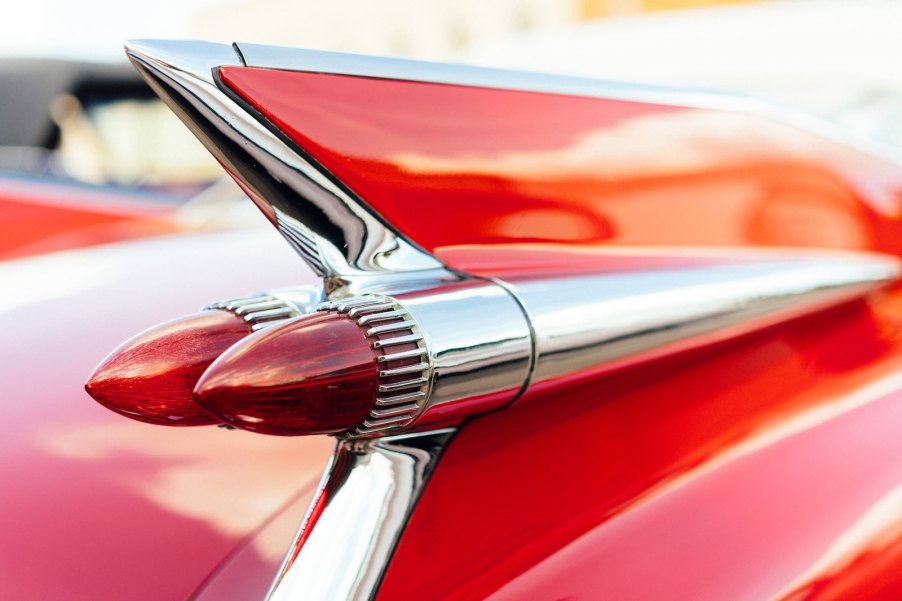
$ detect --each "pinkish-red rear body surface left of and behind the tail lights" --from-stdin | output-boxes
[0,228,332,601]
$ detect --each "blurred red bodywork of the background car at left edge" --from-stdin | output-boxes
[0,173,178,259]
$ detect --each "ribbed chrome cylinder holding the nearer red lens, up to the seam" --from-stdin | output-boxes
[320,280,533,436]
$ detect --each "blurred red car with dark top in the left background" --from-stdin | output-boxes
[0,59,235,260]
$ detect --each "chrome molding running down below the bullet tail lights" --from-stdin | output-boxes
[267,429,455,601]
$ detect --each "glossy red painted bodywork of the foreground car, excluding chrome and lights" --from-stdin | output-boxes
[8,39,902,599]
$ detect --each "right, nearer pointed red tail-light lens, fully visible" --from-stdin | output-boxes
[195,312,378,435]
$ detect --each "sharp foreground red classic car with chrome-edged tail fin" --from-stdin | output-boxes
[0,35,902,600]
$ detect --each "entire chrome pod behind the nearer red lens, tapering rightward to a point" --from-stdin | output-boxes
[251,250,899,438]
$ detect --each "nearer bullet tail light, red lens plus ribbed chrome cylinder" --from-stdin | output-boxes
[194,283,529,437]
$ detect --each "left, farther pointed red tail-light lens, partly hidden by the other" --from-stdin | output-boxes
[85,311,251,426]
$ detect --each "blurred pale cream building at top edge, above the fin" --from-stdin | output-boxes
[188,0,582,59]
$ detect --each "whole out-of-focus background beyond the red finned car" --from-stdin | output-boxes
[0,0,902,258]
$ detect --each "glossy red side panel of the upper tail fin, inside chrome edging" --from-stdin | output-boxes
[220,67,902,267]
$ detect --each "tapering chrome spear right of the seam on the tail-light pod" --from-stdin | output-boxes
[506,251,899,384]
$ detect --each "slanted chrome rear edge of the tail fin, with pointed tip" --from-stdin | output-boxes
[126,40,444,289]
